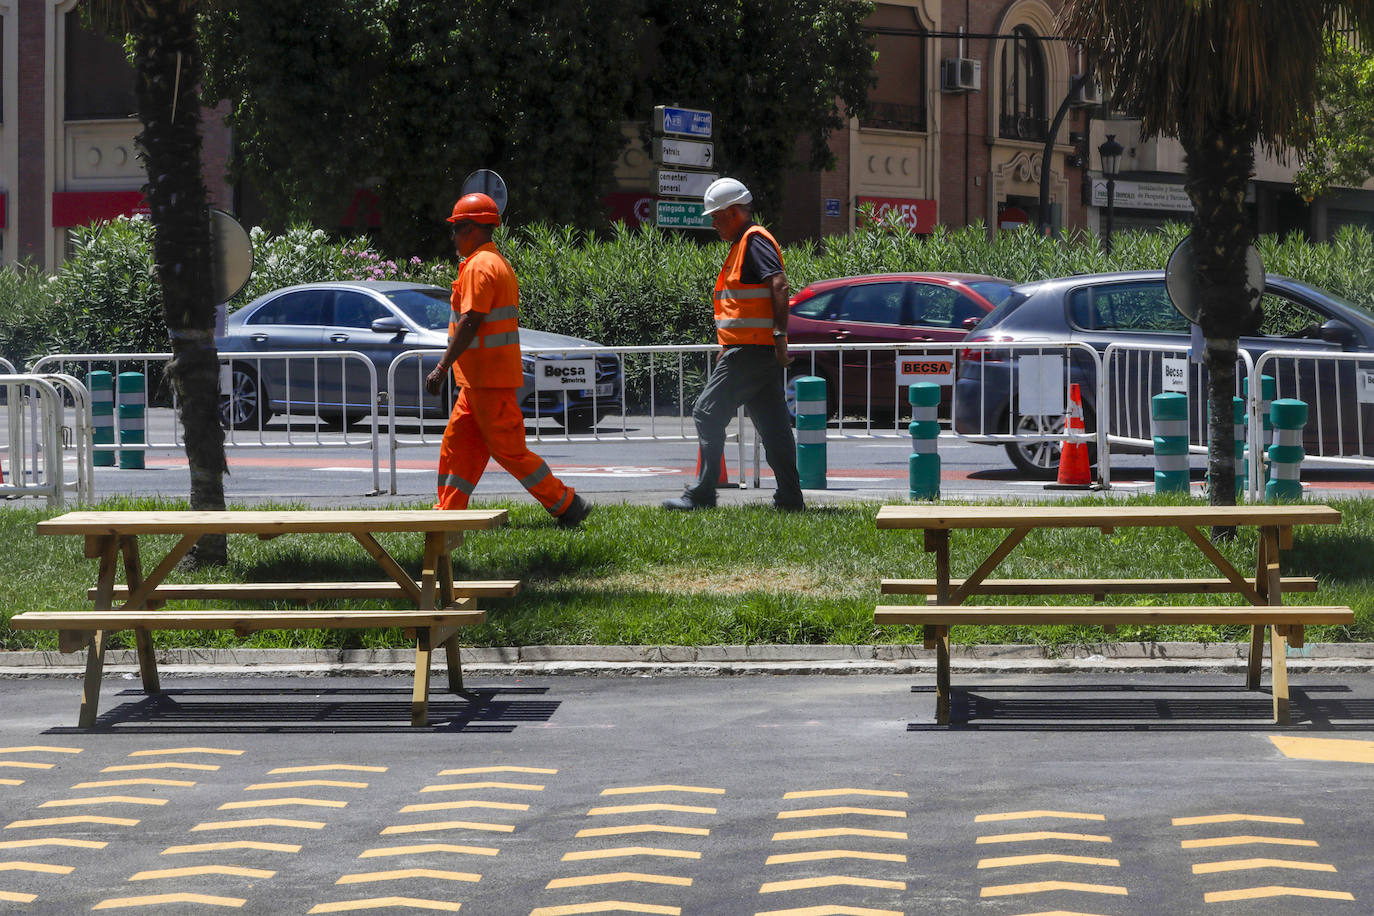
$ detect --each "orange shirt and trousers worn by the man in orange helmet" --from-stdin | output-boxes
[434,242,573,515]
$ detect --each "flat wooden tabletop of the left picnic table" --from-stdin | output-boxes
[37,509,507,536]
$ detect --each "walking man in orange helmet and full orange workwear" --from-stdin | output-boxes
[425,194,592,527]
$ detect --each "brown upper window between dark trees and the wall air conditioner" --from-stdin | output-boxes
[859,3,926,130]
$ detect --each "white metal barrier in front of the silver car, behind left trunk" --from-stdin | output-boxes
[30,350,382,493]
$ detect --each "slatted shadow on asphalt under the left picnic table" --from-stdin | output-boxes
[45,687,561,735]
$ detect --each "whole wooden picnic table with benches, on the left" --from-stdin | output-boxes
[10,509,519,728]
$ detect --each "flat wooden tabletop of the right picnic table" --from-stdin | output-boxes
[877,504,1341,529]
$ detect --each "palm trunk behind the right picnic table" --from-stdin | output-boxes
[1182,121,1256,536]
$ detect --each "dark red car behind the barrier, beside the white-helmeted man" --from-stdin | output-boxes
[787,273,1013,419]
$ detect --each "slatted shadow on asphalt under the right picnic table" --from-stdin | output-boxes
[907,684,1374,732]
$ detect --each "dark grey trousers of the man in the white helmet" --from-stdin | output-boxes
[687,346,802,508]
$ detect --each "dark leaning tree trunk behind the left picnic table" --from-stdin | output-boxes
[131,0,228,566]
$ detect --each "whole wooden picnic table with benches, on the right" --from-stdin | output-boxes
[874,504,1355,724]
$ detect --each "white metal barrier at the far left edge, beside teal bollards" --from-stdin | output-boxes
[0,374,93,507]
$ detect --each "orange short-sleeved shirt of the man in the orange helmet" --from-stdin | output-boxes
[448,242,525,389]
